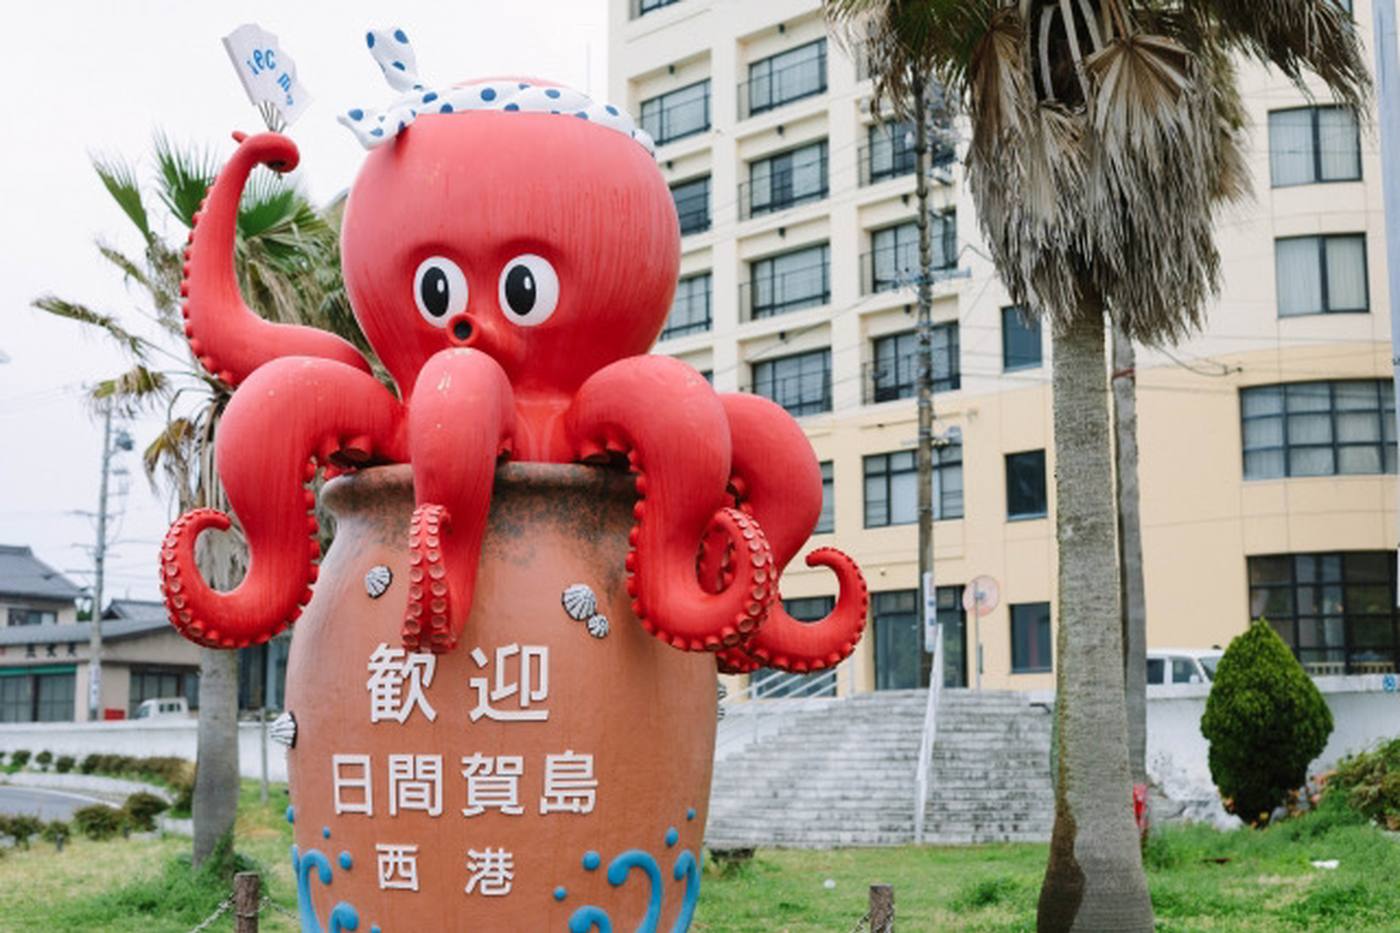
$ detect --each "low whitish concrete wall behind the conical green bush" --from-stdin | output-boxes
[1147,674,1400,827]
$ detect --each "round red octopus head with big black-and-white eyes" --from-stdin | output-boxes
[342,92,680,395]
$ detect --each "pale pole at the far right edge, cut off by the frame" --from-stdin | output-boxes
[1371,0,1400,602]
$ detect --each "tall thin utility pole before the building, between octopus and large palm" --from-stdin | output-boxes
[913,74,944,688]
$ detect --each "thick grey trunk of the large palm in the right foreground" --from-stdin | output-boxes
[1037,308,1152,933]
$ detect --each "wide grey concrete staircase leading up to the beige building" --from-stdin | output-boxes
[706,691,1053,849]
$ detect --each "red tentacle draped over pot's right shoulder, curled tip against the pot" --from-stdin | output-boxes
[566,356,777,651]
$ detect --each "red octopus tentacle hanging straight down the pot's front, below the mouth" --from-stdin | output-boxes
[403,347,515,653]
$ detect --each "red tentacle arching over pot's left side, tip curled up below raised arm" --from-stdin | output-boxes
[161,357,406,647]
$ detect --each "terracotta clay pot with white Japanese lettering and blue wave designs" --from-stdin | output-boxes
[287,464,715,933]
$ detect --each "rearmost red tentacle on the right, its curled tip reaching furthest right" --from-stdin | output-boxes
[720,394,869,672]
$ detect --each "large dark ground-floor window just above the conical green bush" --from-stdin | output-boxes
[1249,551,1400,675]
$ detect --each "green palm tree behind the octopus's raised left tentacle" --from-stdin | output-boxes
[34,134,350,866]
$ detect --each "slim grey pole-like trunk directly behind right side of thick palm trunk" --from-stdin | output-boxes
[1113,321,1147,785]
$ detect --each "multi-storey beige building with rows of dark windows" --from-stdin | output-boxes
[608,0,1400,689]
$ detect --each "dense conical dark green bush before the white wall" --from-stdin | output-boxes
[1201,621,1333,827]
